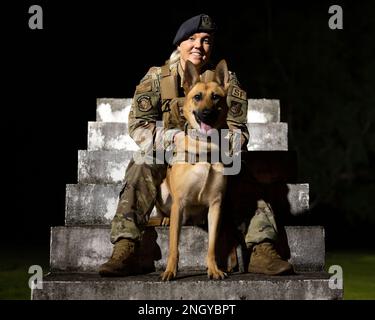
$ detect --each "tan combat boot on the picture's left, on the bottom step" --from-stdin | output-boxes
[99,239,140,277]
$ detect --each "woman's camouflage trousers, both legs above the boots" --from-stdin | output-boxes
[110,160,278,247]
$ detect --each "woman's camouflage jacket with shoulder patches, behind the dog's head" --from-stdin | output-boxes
[129,61,249,154]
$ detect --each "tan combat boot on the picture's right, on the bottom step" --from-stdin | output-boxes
[248,242,294,275]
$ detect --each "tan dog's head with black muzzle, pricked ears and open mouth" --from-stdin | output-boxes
[183,60,229,134]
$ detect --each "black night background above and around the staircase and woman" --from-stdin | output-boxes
[6,1,375,248]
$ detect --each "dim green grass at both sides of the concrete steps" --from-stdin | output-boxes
[0,248,375,300]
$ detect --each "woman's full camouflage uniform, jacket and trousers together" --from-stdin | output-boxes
[111,64,277,247]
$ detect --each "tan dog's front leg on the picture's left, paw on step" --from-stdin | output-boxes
[161,199,181,281]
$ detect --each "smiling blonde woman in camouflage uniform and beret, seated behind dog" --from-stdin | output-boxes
[99,14,291,276]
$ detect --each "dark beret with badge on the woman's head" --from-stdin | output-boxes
[173,14,216,46]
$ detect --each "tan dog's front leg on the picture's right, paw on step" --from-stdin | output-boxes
[207,200,227,279]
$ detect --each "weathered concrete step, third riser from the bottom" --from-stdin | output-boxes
[65,184,309,225]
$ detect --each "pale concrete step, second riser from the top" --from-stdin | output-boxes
[87,122,288,151]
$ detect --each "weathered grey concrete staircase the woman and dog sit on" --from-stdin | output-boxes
[32,99,343,300]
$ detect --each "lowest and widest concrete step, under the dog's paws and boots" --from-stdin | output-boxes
[32,272,343,300]
